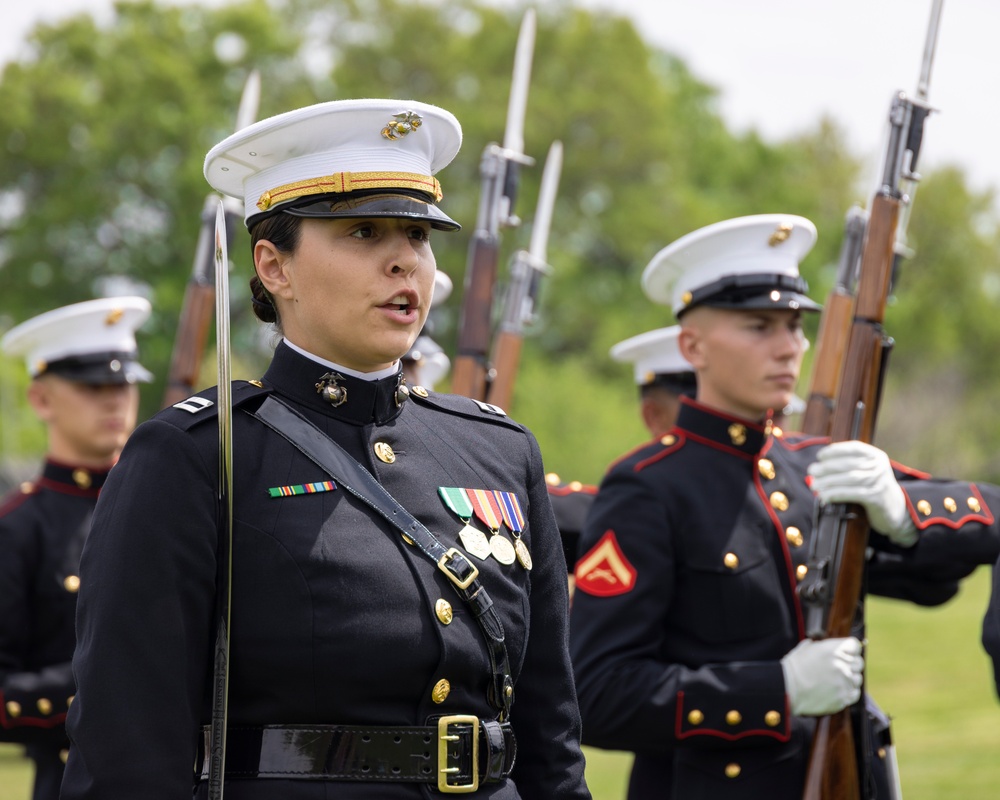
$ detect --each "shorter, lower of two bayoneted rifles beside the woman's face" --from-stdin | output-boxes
[486,141,562,408]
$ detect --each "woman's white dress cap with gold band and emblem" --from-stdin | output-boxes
[205,99,462,227]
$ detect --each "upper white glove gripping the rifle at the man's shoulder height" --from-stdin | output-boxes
[808,441,917,547]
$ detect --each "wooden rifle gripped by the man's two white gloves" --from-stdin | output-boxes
[799,0,943,800]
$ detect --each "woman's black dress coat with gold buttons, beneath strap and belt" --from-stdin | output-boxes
[63,344,589,800]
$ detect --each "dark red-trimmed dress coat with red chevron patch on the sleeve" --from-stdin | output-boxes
[571,400,998,800]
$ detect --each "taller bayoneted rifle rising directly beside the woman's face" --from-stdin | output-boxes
[451,8,535,400]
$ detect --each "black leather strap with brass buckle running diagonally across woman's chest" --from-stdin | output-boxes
[253,395,514,720]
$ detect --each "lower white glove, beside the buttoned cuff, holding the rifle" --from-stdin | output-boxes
[781,636,865,717]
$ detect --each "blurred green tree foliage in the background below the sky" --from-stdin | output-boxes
[0,0,1000,482]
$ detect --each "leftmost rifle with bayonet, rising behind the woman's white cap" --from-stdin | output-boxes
[161,70,260,408]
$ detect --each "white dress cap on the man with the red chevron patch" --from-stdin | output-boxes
[642,214,819,315]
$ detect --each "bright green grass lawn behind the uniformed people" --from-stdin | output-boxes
[0,568,1000,800]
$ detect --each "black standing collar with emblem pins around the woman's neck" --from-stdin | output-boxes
[263,342,409,425]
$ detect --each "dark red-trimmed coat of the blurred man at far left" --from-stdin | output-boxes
[0,460,107,800]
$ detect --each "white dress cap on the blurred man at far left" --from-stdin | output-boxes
[0,297,152,384]
